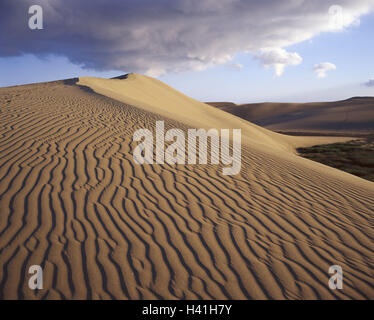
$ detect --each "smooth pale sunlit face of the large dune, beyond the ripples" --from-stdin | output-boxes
[78,73,347,152]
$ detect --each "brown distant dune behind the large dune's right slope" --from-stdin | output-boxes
[209,97,374,132]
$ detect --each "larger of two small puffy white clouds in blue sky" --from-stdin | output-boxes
[255,48,303,77]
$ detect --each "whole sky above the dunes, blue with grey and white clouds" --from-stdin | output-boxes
[0,0,374,103]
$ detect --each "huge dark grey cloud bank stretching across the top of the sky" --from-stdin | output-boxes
[0,0,373,75]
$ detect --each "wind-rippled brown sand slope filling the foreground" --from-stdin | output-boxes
[0,79,374,299]
